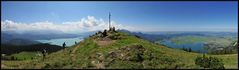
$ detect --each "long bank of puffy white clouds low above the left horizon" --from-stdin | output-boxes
[1,16,134,33]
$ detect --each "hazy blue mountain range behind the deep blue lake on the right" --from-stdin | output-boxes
[119,29,238,42]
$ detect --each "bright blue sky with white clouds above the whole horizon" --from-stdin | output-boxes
[1,1,238,33]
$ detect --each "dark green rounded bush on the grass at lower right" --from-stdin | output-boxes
[195,55,224,69]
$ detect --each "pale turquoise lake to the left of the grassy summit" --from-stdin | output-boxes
[36,37,84,47]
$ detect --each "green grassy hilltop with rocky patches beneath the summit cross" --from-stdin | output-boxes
[1,31,238,69]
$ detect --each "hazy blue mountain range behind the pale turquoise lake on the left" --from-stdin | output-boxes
[1,31,82,45]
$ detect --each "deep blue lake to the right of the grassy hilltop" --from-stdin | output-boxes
[160,40,207,53]
